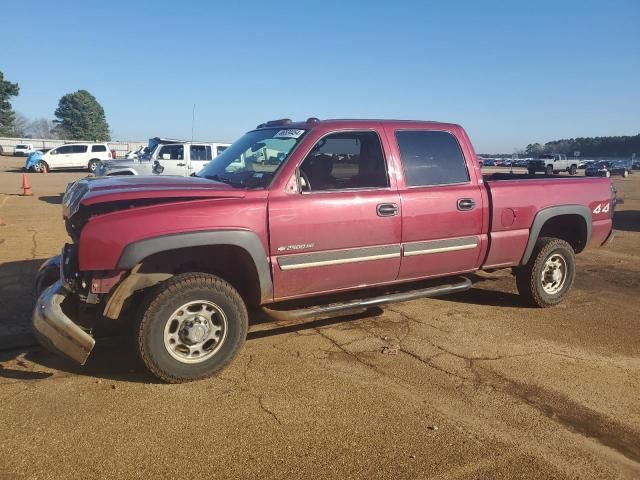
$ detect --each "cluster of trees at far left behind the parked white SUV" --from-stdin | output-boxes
[0,72,111,142]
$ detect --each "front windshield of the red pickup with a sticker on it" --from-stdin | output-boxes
[196,128,305,188]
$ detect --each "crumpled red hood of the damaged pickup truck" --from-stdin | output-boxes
[62,175,246,218]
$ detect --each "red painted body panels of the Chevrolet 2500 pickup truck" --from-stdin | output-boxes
[65,120,612,306]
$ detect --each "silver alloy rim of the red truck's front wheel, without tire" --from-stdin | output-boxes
[164,300,227,363]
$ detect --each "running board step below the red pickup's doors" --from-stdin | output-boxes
[262,278,471,321]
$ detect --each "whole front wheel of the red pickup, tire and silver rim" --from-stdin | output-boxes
[134,273,248,383]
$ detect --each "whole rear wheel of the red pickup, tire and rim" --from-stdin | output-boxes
[516,237,576,308]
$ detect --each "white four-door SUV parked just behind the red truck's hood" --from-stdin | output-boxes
[95,142,229,176]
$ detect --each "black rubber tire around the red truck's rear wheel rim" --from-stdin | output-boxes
[516,237,576,308]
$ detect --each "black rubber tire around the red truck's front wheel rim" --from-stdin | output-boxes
[134,273,248,383]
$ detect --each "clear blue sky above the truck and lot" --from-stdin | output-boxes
[0,0,640,153]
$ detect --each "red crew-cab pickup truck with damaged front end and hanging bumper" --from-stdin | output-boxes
[33,118,616,382]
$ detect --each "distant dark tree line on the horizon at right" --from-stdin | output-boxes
[525,134,640,157]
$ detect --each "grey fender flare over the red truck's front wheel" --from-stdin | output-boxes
[117,230,273,303]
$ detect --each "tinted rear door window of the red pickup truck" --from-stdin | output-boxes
[396,130,469,187]
